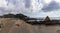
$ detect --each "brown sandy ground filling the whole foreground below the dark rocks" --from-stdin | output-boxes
[0,18,60,33]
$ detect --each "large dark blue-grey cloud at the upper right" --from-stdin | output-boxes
[42,1,60,12]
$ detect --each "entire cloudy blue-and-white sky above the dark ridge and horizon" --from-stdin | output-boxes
[0,0,60,18]
